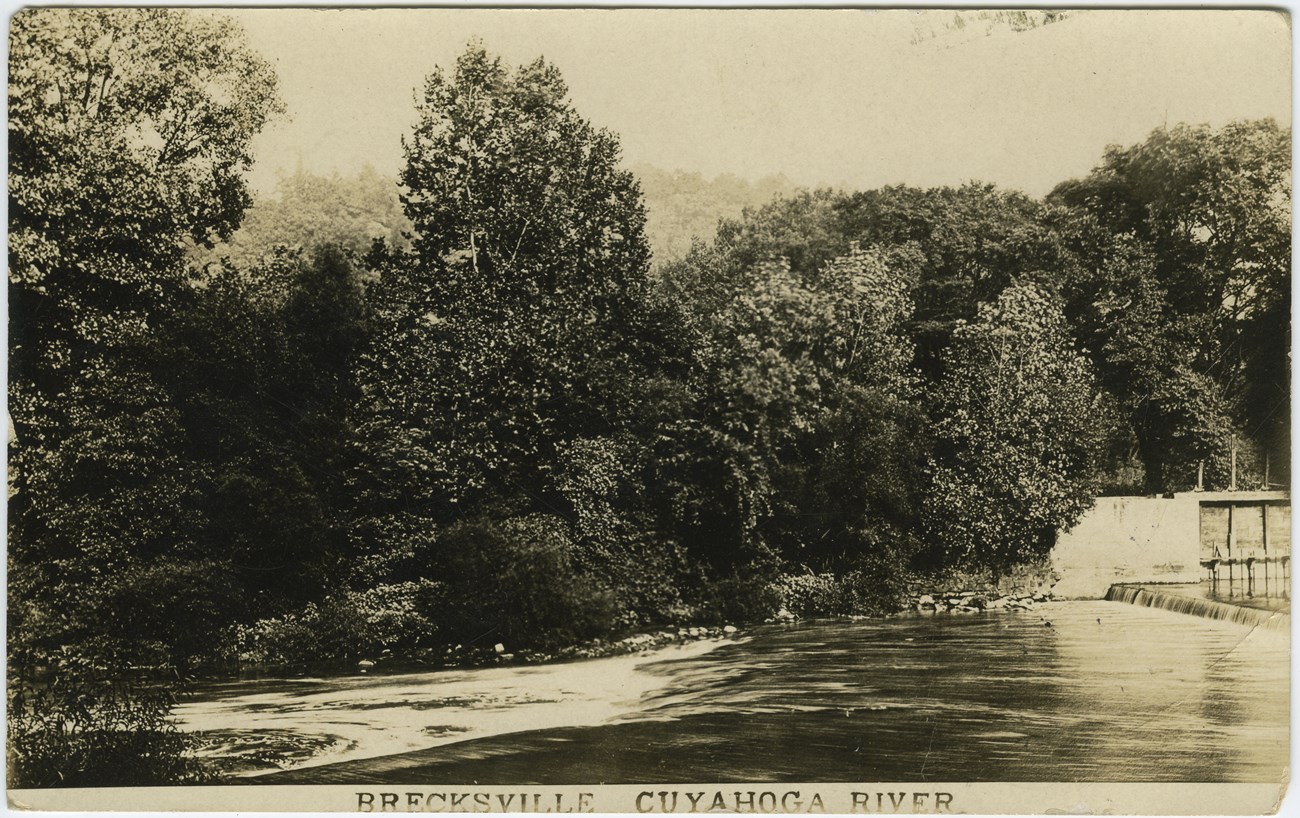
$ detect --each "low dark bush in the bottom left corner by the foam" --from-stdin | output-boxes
[8,653,209,787]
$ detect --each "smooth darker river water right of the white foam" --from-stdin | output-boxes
[228,602,1290,784]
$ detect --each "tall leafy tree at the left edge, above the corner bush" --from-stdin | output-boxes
[9,9,280,663]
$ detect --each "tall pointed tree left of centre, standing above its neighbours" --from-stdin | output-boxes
[356,44,683,587]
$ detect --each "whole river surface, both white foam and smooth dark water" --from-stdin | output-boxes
[178,601,1290,784]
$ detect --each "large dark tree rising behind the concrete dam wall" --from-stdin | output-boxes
[1049,120,1291,492]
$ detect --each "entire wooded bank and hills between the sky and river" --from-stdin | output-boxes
[8,9,1291,785]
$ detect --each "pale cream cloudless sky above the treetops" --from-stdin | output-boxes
[224,9,1291,195]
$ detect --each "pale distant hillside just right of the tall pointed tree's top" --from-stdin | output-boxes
[632,164,797,264]
